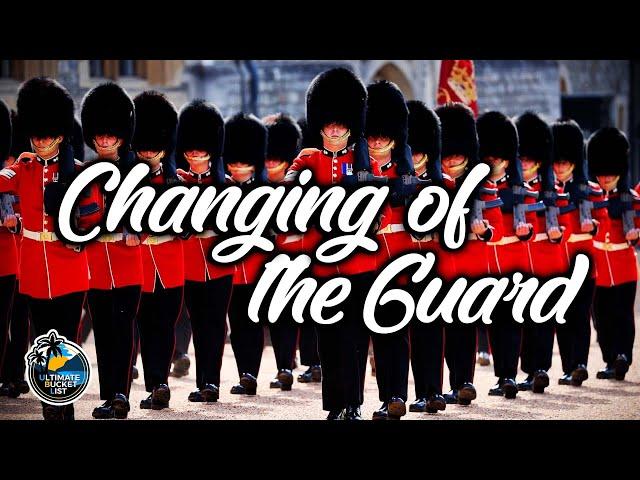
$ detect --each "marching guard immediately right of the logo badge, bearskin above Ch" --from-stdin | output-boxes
[80,82,143,419]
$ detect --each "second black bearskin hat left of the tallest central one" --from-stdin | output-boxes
[223,112,267,178]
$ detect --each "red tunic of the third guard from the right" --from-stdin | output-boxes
[526,177,570,277]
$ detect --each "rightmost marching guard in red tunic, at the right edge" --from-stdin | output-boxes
[587,127,640,380]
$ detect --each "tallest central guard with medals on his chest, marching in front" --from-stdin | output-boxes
[285,68,381,420]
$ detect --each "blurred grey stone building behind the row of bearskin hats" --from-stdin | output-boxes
[0,60,640,180]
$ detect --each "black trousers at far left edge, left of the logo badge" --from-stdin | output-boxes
[0,285,30,382]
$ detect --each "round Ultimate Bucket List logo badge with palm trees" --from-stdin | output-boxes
[24,330,91,405]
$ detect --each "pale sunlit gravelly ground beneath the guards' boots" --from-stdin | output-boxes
[0,288,640,420]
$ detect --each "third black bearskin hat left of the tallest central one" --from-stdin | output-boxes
[176,99,224,170]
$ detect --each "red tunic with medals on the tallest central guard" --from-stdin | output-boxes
[288,148,388,277]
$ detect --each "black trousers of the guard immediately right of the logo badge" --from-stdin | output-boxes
[87,286,141,400]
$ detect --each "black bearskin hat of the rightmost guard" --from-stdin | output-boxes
[587,127,629,177]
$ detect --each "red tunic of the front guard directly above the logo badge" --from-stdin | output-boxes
[0,158,89,299]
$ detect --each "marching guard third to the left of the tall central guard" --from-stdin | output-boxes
[174,99,234,402]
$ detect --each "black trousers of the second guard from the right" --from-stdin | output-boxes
[556,278,595,374]
